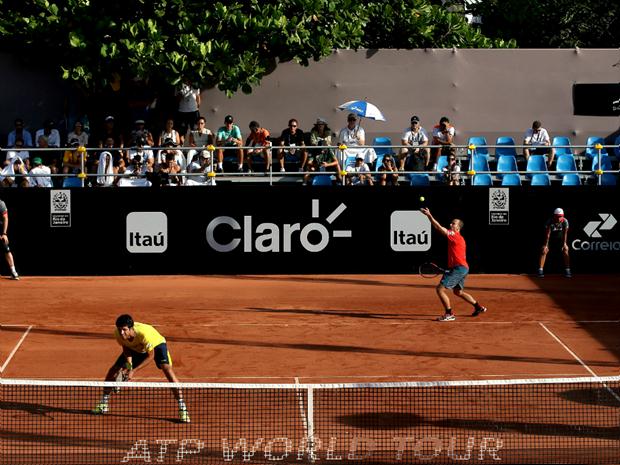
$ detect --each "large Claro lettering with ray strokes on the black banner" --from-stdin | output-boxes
[207,199,352,253]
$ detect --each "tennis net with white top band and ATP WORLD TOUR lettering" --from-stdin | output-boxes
[0,377,620,465]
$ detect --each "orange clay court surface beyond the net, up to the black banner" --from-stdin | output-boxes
[0,275,620,384]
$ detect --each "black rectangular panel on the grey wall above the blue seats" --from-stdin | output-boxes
[573,83,620,116]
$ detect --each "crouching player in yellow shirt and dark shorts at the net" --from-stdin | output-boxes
[93,315,190,423]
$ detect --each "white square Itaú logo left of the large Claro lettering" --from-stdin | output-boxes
[126,212,168,253]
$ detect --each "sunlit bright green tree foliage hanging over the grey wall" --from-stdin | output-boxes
[0,0,510,94]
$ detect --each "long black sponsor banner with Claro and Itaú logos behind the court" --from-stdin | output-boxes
[0,184,620,276]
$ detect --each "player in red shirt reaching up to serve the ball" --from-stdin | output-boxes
[420,208,487,321]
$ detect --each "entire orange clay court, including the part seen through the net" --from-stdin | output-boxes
[0,275,620,464]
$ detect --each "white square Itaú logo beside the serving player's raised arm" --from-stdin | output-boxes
[390,210,431,252]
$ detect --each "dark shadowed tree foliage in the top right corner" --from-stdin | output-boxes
[473,0,620,48]
